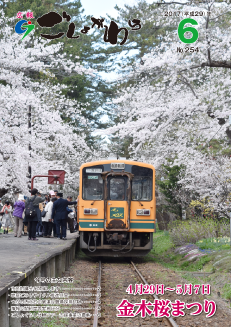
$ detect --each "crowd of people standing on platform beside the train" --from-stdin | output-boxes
[0,188,78,241]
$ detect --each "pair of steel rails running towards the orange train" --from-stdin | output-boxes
[93,261,179,327]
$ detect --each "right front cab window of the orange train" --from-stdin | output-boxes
[132,166,153,201]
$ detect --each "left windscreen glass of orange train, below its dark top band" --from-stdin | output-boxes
[83,174,103,200]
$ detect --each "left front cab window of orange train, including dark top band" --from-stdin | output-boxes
[83,166,103,200]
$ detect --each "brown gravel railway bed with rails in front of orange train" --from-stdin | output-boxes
[19,258,231,327]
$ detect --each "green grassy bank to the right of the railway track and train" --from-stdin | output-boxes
[144,231,231,307]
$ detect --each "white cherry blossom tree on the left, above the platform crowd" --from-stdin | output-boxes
[0,11,93,197]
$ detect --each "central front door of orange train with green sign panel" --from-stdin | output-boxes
[105,175,130,230]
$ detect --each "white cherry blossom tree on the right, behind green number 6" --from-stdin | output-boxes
[104,1,231,216]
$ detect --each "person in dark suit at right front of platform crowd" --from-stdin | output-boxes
[52,193,77,240]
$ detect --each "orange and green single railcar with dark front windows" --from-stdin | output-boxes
[77,160,156,257]
